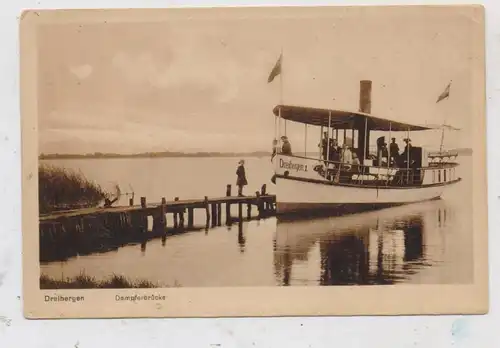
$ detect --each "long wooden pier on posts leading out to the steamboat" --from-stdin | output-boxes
[39,185,276,261]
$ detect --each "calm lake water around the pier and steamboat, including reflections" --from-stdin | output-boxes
[41,157,473,286]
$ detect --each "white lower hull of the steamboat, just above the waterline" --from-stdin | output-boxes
[276,177,460,214]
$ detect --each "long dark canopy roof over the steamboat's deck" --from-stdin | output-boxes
[273,105,434,132]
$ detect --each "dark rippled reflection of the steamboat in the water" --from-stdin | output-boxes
[274,200,451,286]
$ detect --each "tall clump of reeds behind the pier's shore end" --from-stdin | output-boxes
[38,164,109,214]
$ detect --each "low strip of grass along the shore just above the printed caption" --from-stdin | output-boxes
[40,273,159,289]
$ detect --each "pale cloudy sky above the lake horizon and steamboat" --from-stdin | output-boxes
[38,9,476,153]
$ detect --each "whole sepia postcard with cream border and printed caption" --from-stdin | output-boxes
[20,6,488,318]
